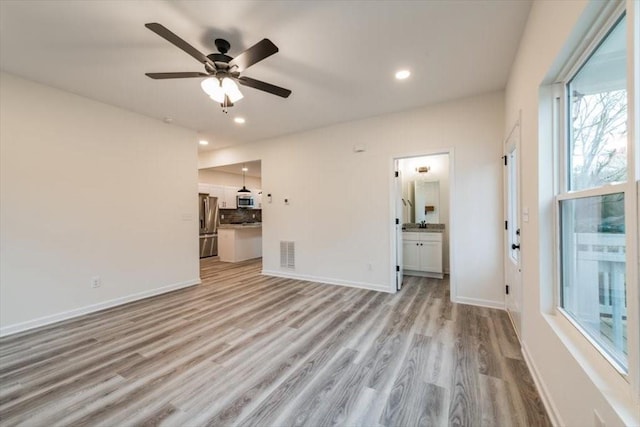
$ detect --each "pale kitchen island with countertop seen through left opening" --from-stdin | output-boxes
[218,226,262,262]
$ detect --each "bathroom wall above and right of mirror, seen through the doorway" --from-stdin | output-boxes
[399,154,450,273]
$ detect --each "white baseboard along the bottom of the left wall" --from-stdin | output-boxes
[0,277,201,337]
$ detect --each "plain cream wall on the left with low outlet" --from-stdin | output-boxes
[0,73,199,334]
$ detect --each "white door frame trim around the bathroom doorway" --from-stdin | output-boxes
[389,147,458,301]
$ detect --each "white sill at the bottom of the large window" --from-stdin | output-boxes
[542,313,640,425]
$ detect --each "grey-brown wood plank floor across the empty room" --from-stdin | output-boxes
[0,259,550,426]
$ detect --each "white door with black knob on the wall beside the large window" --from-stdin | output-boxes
[504,122,522,335]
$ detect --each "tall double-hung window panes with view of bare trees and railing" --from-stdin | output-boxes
[557,16,637,373]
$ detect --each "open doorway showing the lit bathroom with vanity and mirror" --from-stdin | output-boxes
[392,150,455,295]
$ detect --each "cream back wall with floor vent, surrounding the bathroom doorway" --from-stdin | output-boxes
[199,92,504,306]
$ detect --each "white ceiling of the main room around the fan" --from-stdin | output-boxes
[0,0,531,150]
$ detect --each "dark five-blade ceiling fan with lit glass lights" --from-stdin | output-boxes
[145,22,291,109]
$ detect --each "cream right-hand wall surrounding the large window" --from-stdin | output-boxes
[503,1,640,426]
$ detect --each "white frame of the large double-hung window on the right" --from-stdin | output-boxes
[552,2,640,396]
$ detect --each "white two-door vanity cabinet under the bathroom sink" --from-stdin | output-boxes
[402,232,443,279]
